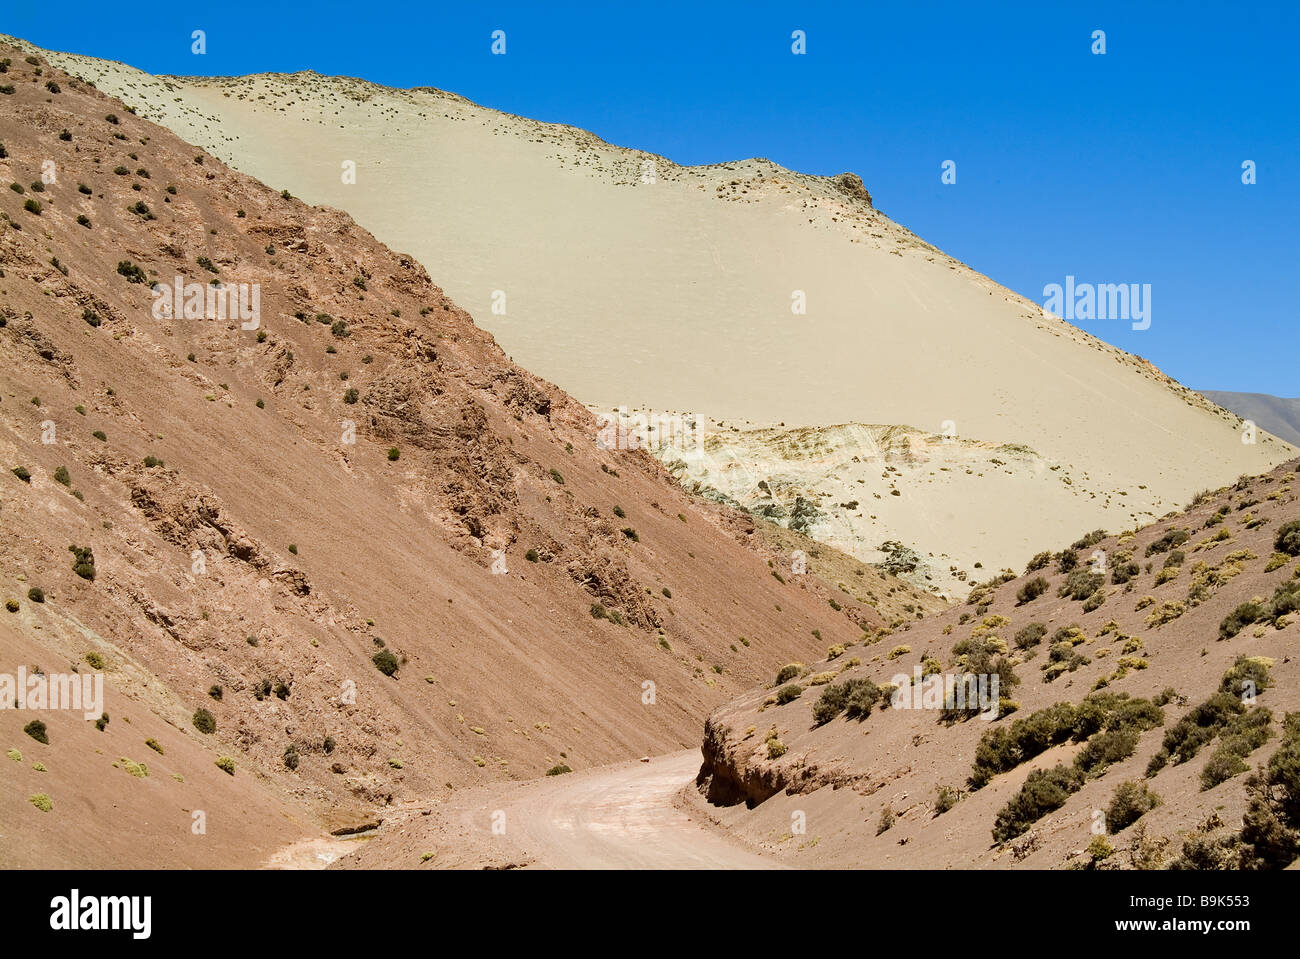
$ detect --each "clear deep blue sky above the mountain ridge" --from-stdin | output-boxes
[0,0,1300,396]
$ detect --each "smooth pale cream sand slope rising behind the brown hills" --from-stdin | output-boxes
[15,39,1295,587]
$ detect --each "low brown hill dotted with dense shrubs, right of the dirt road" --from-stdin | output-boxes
[694,463,1300,868]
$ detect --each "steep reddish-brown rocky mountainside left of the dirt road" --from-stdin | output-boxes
[0,45,935,867]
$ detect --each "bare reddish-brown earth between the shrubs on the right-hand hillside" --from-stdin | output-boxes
[690,461,1300,868]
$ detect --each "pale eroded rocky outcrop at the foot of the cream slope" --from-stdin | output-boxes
[650,422,1149,598]
